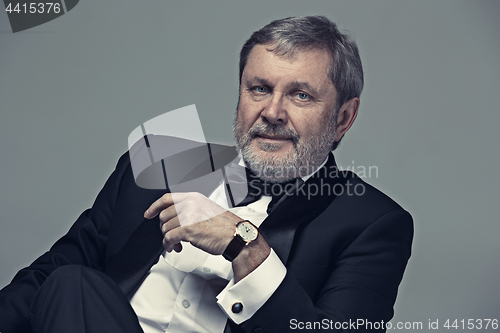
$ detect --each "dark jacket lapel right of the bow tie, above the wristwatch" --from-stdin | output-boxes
[259,154,345,265]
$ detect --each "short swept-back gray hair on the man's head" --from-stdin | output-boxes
[240,16,363,149]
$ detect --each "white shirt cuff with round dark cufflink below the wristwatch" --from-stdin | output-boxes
[217,249,286,324]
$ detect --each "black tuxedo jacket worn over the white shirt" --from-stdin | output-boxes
[0,154,413,333]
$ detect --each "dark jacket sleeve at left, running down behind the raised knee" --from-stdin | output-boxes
[0,154,130,333]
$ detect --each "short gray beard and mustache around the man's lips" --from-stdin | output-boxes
[233,112,337,183]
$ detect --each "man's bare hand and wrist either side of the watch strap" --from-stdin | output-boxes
[144,192,271,282]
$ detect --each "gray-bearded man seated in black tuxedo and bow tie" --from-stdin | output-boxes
[0,17,413,333]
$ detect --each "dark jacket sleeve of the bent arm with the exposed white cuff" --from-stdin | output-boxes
[237,209,413,333]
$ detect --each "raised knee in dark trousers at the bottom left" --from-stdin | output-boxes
[30,265,143,333]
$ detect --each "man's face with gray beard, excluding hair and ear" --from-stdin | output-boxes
[234,45,338,182]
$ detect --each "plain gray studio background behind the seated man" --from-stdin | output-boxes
[0,0,500,331]
